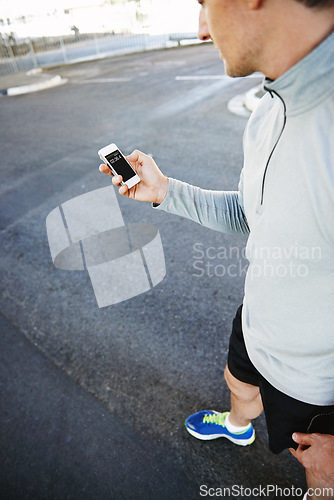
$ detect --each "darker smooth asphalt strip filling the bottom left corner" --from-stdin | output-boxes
[0,317,198,500]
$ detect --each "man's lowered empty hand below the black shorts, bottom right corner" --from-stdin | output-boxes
[290,432,334,488]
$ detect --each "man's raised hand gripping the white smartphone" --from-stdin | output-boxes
[100,150,168,204]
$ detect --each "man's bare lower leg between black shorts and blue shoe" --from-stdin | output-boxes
[224,366,263,427]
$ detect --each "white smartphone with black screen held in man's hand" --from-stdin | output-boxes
[98,144,140,188]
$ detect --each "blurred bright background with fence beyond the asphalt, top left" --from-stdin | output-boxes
[0,0,199,75]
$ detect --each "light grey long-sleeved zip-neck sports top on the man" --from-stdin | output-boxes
[158,33,334,405]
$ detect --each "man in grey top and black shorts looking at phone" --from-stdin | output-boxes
[100,0,334,500]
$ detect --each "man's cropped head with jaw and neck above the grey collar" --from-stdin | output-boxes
[198,0,334,79]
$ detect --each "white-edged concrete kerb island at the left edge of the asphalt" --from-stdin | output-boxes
[0,68,67,96]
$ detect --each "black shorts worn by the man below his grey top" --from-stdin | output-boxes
[227,306,334,453]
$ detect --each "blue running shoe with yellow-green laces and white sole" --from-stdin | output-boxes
[185,410,255,446]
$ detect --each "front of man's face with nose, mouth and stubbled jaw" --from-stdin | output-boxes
[198,0,259,76]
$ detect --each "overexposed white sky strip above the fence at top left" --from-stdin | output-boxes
[0,0,199,38]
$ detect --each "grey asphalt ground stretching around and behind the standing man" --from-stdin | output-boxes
[0,45,305,500]
